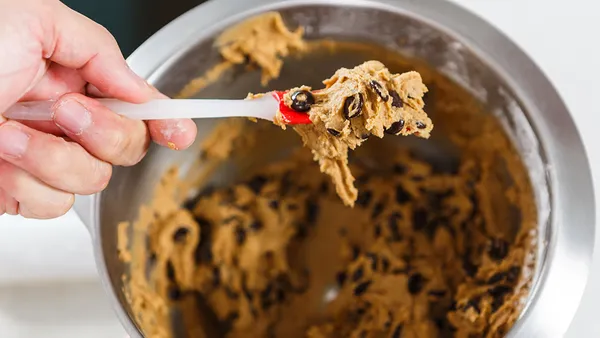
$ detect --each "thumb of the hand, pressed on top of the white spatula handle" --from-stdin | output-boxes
[43,1,154,103]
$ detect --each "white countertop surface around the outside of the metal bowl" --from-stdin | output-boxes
[0,0,600,338]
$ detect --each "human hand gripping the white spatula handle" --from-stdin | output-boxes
[0,0,196,219]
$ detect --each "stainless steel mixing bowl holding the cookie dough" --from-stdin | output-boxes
[75,0,595,338]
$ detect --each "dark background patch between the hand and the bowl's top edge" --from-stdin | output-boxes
[62,0,207,57]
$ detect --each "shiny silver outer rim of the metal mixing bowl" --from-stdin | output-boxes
[86,0,595,338]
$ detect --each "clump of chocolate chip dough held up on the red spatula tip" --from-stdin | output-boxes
[275,61,433,207]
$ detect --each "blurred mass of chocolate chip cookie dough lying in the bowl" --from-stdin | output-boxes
[119,145,530,338]
